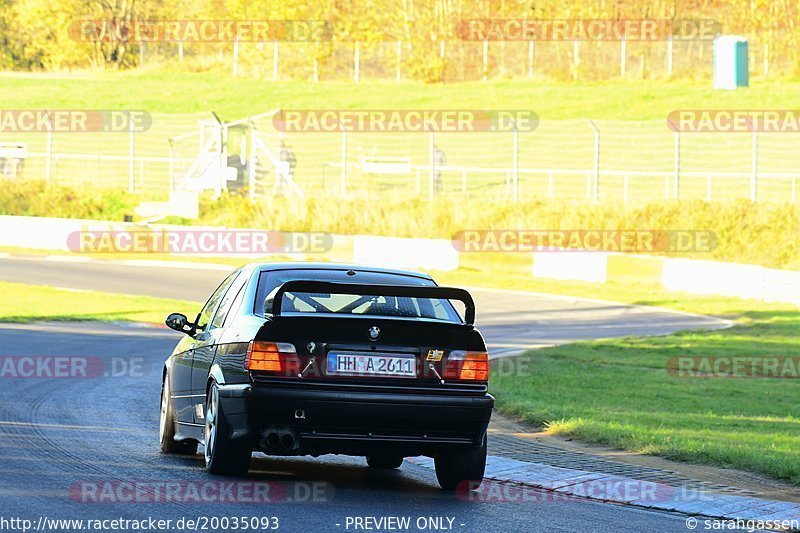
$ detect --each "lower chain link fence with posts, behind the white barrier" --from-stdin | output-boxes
[0,112,800,203]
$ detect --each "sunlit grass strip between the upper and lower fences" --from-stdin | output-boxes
[0,70,800,120]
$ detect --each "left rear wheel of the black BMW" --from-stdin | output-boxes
[203,382,252,476]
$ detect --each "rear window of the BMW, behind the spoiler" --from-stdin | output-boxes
[254,269,461,322]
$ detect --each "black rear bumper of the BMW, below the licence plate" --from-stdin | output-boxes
[220,385,494,456]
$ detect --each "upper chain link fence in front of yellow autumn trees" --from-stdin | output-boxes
[139,37,798,83]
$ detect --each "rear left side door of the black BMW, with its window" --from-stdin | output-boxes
[191,271,248,424]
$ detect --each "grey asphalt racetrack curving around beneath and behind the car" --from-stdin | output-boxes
[0,258,725,532]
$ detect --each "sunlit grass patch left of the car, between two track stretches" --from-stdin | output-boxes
[0,281,202,323]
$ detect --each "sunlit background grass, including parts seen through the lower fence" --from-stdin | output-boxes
[6,70,800,202]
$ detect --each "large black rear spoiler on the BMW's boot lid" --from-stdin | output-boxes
[272,280,475,325]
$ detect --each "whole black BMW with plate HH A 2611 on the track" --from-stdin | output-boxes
[160,263,494,488]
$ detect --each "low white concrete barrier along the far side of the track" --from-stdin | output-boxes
[0,216,800,305]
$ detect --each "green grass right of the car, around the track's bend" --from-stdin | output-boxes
[491,287,800,485]
